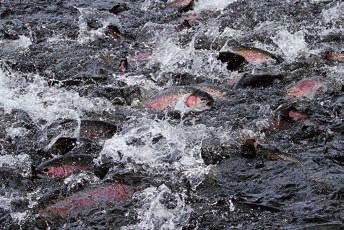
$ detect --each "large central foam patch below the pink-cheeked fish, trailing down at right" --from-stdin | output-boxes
[98,118,209,187]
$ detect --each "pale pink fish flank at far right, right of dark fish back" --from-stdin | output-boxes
[288,78,325,99]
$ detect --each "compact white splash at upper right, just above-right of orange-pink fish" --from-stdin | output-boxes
[273,30,308,61]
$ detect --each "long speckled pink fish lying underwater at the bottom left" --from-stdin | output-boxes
[39,184,134,218]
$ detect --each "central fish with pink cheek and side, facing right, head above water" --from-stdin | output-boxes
[143,86,214,112]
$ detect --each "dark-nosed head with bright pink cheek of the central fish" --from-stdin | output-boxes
[185,90,214,111]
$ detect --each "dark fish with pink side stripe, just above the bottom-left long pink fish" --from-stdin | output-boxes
[34,154,93,178]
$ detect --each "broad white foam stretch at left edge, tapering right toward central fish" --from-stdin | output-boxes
[0,69,111,123]
